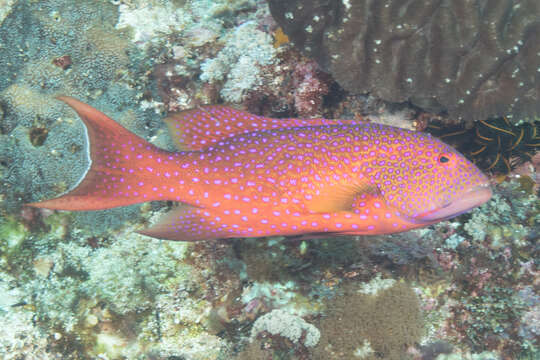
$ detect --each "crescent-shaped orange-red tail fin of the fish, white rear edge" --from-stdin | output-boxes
[27,96,178,210]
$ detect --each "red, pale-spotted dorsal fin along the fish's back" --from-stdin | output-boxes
[164,105,346,151]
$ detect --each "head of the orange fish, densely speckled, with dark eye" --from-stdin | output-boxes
[377,133,492,224]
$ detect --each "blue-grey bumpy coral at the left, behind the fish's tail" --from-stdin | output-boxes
[0,1,162,230]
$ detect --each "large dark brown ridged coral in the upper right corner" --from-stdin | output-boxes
[269,0,540,121]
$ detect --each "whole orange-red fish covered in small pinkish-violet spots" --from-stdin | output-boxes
[29,97,491,241]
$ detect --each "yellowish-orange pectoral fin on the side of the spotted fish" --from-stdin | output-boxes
[306,183,379,213]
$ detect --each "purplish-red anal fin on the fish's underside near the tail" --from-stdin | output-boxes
[137,204,230,241]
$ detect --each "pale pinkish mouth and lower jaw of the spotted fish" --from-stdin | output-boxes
[418,183,493,222]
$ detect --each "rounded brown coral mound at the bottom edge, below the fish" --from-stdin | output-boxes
[313,282,423,360]
